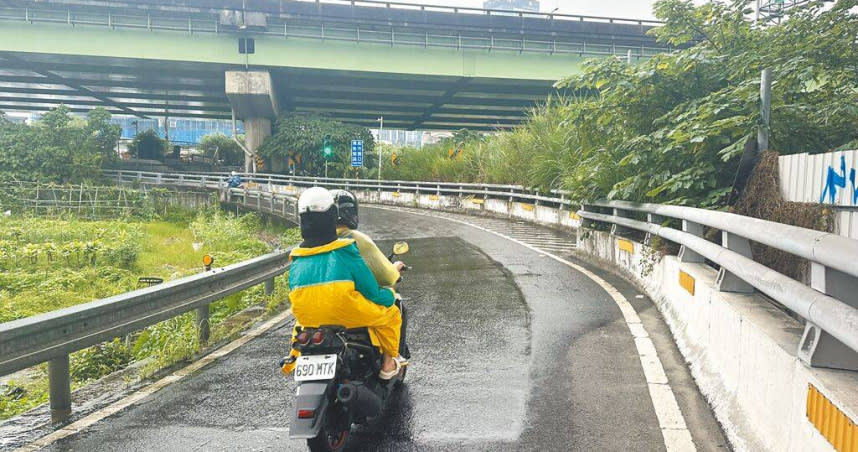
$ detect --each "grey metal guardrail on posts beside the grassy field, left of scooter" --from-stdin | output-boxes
[0,247,288,421]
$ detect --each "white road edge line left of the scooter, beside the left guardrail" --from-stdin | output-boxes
[15,309,292,452]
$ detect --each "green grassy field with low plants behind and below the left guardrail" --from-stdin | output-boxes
[0,210,298,420]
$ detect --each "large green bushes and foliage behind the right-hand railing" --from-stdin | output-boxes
[384,0,858,206]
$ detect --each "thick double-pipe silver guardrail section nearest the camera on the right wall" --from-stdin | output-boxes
[578,201,858,370]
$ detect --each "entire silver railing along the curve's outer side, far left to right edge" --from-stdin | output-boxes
[110,171,858,369]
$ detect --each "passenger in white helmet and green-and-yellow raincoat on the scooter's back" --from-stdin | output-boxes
[289,187,404,380]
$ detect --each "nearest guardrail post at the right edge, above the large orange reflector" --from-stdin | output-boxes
[798,262,858,370]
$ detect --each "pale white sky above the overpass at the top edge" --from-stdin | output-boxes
[392,0,699,19]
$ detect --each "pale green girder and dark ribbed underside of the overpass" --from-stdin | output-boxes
[0,3,660,130]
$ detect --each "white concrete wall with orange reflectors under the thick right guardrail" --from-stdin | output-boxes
[578,231,858,451]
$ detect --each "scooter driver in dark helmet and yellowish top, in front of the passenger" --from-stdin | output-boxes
[331,190,405,287]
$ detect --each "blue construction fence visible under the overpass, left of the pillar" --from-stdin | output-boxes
[110,117,244,146]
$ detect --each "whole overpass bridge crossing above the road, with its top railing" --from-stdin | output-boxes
[0,0,667,134]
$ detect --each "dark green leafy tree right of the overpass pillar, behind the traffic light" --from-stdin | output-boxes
[258,113,377,177]
